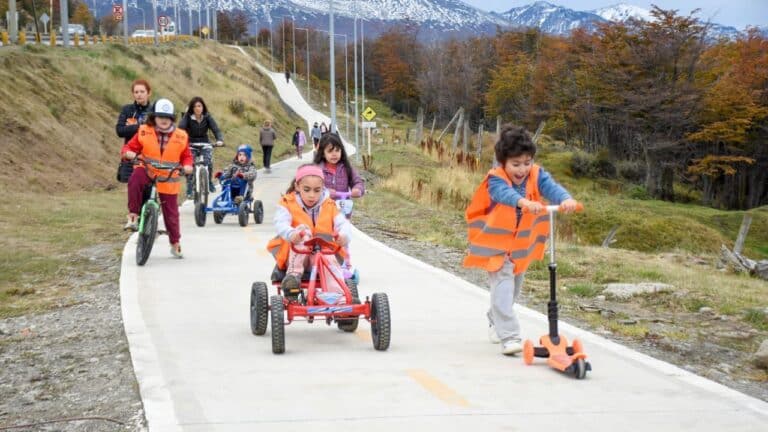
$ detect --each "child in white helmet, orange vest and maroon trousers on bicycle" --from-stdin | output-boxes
[122,99,193,258]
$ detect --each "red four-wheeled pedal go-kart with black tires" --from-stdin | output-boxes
[250,233,391,354]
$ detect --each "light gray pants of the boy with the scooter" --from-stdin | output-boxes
[488,260,525,342]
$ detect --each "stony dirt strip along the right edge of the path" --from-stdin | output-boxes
[354,210,768,401]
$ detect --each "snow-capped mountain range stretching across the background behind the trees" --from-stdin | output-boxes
[99,0,739,39]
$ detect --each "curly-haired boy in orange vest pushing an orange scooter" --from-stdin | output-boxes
[463,125,577,355]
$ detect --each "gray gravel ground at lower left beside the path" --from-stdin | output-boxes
[0,244,146,432]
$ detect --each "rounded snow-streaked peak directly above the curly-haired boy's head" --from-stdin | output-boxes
[499,1,605,34]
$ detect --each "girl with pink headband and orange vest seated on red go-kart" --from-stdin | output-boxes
[267,165,351,296]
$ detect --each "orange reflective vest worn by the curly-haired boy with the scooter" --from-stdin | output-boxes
[463,164,549,274]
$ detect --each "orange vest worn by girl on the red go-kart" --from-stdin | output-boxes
[267,192,345,270]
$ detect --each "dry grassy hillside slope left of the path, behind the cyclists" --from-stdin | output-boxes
[0,42,302,192]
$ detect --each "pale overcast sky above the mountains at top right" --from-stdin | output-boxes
[463,0,768,30]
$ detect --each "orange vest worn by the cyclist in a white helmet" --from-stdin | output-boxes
[137,125,189,195]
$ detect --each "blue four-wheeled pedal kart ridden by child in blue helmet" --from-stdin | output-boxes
[195,177,264,227]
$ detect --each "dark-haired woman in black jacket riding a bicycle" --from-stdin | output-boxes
[179,96,224,199]
